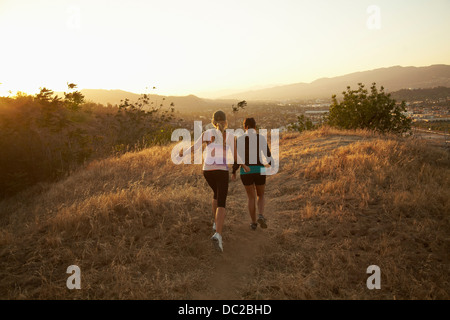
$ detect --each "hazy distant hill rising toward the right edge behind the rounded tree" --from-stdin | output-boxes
[224,65,450,100]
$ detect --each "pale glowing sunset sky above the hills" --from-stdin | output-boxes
[0,0,450,98]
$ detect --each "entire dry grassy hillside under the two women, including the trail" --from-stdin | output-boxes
[0,128,450,299]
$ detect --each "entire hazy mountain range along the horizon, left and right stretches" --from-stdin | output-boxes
[70,65,450,107]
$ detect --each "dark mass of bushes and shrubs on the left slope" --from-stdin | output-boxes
[0,84,178,198]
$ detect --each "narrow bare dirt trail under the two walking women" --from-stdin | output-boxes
[192,181,276,300]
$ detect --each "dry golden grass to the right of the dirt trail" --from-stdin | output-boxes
[247,129,450,299]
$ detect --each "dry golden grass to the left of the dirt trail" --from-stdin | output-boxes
[0,147,211,299]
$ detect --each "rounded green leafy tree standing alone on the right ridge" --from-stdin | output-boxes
[328,83,411,133]
